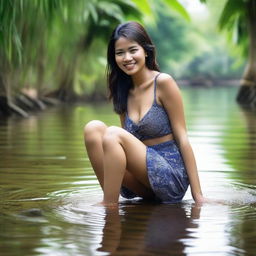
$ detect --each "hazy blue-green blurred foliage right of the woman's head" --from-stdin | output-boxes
[148,4,243,80]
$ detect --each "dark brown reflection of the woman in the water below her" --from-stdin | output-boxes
[98,204,200,255]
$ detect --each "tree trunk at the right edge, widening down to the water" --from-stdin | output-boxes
[237,0,256,109]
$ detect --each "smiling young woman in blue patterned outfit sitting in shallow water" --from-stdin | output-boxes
[84,22,205,206]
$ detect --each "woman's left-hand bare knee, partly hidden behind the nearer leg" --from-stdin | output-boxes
[84,120,107,141]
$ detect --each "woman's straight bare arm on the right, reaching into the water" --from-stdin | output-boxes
[157,74,204,203]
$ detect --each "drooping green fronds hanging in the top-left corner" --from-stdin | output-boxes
[0,0,64,64]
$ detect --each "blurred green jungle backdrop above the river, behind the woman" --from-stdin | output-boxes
[0,0,256,113]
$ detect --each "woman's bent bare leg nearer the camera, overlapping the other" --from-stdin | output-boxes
[103,126,152,204]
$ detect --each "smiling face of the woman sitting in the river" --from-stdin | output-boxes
[115,37,146,75]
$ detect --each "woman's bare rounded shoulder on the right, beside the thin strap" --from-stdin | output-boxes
[157,73,179,95]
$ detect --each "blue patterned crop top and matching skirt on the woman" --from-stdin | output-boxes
[121,74,189,203]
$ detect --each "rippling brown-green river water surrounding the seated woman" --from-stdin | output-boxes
[0,87,256,256]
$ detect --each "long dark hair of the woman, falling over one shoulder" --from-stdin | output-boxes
[107,21,159,114]
